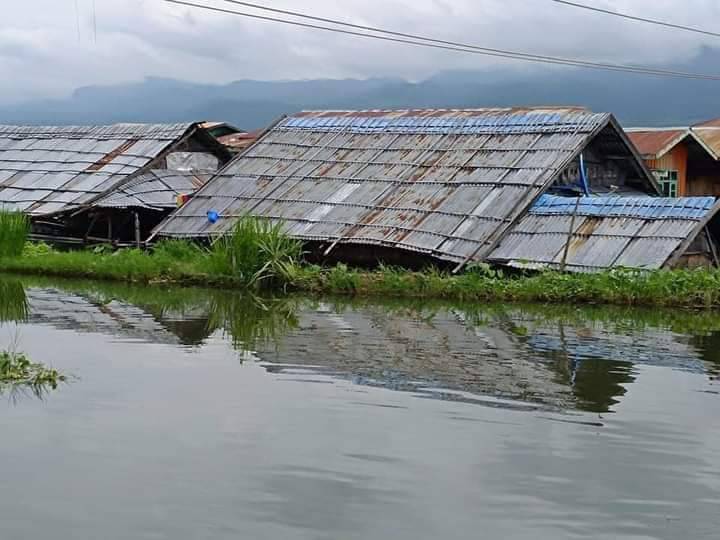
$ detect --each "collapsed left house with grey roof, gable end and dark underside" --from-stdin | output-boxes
[0,123,230,239]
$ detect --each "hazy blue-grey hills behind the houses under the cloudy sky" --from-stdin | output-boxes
[0,49,720,130]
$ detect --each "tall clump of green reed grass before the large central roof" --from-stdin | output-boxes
[208,216,302,288]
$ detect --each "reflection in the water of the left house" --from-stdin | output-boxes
[26,289,211,346]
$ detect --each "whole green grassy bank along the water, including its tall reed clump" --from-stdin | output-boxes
[0,215,720,307]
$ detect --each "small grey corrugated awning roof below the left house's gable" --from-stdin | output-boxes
[93,169,211,210]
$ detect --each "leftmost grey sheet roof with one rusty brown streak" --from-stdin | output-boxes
[0,123,196,215]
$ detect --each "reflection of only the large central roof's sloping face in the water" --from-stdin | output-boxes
[260,306,571,406]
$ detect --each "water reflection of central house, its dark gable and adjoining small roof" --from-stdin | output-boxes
[253,306,716,412]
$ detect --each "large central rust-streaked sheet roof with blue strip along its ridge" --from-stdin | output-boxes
[156,108,640,263]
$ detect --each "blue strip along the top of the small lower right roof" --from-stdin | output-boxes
[530,195,716,220]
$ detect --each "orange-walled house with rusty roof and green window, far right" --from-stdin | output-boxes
[627,119,720,197]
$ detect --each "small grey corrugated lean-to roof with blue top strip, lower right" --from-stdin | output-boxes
[489,195,717,272]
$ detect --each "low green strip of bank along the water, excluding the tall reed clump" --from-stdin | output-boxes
[0,250,720,309]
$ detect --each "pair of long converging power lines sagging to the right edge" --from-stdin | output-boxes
[163,0,720,81]
